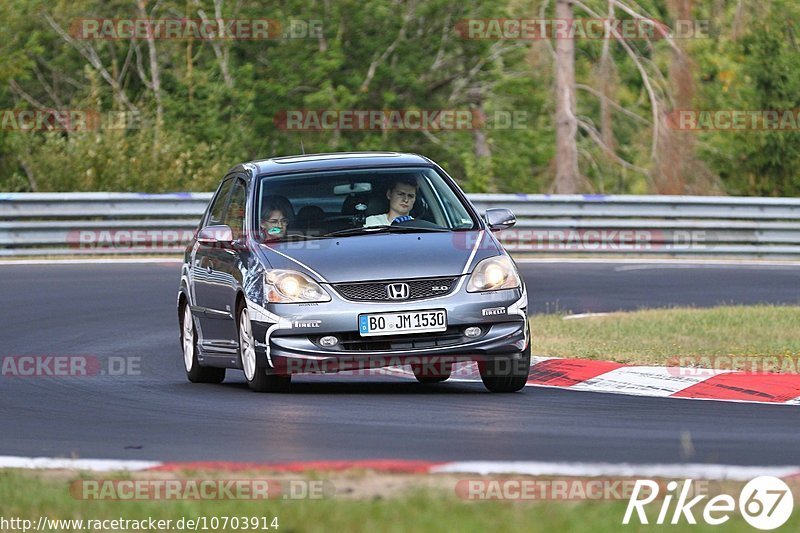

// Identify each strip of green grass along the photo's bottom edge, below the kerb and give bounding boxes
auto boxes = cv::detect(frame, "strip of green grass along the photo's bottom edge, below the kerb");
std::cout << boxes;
[0,470,800,533]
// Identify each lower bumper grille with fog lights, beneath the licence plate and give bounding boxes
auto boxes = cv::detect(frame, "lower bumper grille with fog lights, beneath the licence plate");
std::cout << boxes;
[311,327,486,352]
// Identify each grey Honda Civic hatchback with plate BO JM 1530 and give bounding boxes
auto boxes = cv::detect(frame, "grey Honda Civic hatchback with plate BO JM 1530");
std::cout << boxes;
[177,152,531,392]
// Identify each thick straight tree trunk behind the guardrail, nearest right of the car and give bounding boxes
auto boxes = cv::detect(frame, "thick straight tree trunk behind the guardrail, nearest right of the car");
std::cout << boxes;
[555,0,580,194]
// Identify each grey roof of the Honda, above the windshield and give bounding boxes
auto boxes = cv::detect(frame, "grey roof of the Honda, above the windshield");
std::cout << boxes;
[231,152,433,175]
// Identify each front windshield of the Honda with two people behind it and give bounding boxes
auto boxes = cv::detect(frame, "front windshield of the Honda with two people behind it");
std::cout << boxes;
[257,167,477,241]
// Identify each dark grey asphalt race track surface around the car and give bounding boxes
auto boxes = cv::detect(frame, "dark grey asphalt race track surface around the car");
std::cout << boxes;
[0,263,800,465]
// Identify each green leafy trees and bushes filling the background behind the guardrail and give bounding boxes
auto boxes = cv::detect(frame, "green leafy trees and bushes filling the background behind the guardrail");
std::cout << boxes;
[0,0,800,195]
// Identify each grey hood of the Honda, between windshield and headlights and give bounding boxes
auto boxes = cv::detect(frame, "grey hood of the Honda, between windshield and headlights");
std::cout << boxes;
[259,231,499,283]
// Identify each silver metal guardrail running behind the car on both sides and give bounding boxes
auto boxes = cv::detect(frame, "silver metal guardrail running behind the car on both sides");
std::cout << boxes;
[0,193,800,259]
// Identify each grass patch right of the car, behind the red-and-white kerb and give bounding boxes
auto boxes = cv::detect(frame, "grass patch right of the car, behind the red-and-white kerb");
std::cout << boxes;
[531,306,800,369]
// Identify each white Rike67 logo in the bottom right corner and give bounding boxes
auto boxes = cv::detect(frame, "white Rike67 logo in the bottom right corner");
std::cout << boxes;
[622,476,794,531]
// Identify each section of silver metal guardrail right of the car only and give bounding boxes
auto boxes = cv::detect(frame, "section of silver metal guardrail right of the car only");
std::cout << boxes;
[484,195,800,259]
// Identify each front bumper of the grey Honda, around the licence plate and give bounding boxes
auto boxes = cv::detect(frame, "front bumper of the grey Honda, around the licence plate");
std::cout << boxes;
[248,287,529,374]
